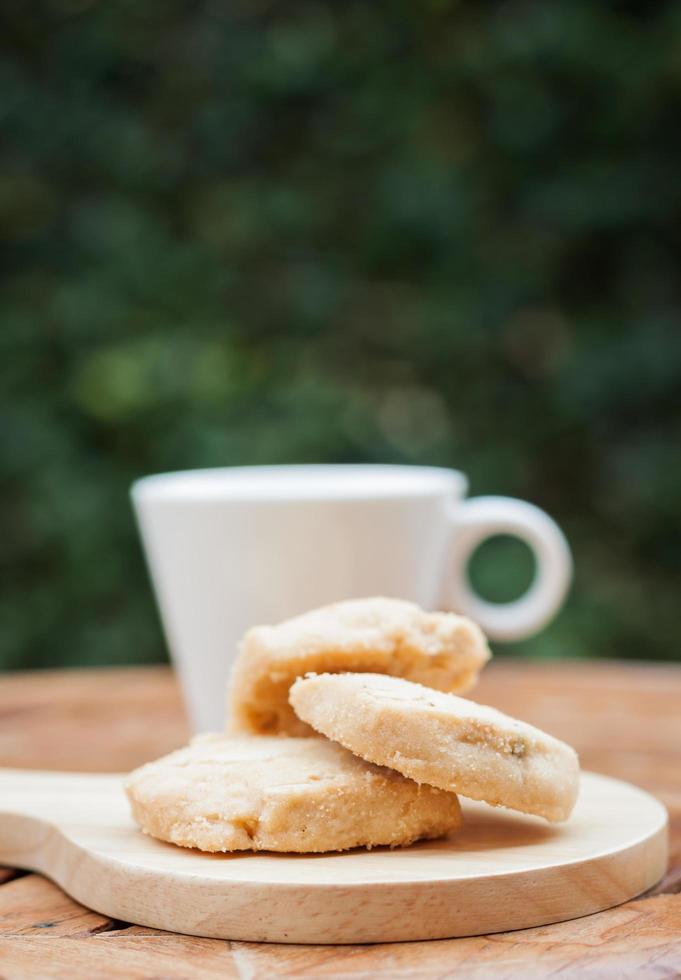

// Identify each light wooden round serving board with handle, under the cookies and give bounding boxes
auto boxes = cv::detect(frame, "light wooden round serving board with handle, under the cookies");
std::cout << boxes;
[0,769,667,943]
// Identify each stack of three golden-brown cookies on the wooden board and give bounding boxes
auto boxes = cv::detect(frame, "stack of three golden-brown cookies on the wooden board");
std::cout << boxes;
[127,598,579,853]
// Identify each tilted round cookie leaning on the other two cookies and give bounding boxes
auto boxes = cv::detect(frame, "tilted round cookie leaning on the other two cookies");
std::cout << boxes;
[290,674,579,821]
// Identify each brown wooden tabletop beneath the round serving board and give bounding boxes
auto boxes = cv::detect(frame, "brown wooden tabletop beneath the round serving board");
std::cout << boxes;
[0,660,681,980]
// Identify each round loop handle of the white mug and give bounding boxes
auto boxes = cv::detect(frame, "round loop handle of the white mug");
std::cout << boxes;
[445,497,572,640]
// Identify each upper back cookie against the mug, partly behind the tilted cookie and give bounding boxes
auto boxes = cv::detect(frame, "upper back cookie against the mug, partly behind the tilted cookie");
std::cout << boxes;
[229,598,490,735]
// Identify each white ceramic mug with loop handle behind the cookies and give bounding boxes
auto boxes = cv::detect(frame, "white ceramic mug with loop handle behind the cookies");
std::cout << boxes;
[132,465,572,730]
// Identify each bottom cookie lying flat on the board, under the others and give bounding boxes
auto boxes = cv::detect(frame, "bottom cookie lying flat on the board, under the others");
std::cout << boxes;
[126,735,461,853]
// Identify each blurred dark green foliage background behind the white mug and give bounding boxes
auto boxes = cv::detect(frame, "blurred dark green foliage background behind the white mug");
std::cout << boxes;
[0,0,681,668]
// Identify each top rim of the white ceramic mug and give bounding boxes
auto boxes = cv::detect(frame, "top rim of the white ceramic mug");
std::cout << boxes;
[130,463,468,504]
